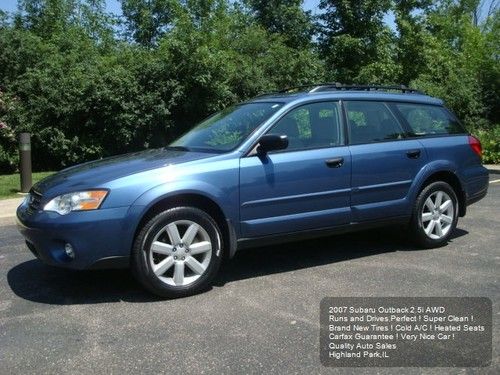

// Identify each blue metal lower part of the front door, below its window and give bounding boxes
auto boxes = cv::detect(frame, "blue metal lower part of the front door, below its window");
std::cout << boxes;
[240,146,351,237]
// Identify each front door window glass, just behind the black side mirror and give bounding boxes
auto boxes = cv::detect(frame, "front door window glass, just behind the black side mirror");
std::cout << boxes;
[268,102,342,150]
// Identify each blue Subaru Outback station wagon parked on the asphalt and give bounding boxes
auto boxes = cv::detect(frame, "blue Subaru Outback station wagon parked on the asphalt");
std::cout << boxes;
[17,84,488,297]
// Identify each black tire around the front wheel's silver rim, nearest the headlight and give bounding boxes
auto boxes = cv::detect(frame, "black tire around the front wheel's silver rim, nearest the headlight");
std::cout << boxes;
[131,207,223,298]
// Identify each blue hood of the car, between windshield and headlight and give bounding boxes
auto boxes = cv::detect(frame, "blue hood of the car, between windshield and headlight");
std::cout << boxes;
[33,148,215,194]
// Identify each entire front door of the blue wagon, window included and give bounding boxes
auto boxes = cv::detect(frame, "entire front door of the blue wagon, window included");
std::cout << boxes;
[240,102,351,238]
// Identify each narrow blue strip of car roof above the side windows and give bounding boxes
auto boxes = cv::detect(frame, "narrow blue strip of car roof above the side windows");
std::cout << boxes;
[247,90,443,105]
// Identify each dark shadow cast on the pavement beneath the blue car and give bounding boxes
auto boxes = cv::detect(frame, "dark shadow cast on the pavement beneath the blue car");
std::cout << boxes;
[7,228,468,305]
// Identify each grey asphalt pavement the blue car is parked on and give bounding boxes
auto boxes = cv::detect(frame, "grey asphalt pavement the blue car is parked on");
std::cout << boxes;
[0,174,500,374]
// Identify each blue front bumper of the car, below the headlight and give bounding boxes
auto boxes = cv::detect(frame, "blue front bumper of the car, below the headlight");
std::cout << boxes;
[17,203,134,269]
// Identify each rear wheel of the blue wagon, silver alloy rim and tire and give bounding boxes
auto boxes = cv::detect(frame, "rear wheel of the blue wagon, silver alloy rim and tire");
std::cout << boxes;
[410,181,459,248]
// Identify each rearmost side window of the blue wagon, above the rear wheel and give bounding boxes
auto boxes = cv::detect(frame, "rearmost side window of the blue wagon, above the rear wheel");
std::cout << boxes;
[396,103,464,136]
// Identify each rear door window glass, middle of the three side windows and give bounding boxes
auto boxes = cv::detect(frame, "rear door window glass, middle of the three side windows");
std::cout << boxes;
[345,101,404,144]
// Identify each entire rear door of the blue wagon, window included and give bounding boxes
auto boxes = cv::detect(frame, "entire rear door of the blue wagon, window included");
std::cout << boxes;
[344,101,427,222]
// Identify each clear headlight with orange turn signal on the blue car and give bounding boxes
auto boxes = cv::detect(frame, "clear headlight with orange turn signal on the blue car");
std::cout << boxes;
[43,190,108,215]
